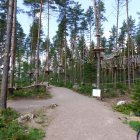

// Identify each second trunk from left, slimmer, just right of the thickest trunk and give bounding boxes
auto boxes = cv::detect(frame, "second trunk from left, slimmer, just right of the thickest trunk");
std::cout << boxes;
[10,0,17,91]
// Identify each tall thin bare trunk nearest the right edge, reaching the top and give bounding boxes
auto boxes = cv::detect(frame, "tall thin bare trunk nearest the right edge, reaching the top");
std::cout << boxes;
[126,0,131,89]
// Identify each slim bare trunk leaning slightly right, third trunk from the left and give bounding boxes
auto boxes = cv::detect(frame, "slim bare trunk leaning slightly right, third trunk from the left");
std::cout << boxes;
[36,0,43,84]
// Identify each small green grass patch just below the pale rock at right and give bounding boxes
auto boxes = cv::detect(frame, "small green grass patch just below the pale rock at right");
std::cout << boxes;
[113,104,132,115]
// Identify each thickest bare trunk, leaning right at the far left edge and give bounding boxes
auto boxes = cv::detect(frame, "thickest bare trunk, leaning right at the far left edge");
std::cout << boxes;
[0,0,14,108]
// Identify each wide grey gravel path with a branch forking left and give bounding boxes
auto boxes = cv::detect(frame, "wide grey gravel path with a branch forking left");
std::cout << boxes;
[8,87,136,140]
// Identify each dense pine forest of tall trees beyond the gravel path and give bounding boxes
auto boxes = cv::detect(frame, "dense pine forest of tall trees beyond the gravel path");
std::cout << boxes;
[0,0,140,113]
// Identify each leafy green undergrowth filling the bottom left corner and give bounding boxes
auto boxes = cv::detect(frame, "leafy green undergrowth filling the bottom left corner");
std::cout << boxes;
[0,108,45,140]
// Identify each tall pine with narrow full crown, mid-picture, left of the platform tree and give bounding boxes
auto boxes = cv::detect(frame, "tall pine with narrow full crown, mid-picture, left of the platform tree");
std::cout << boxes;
[68,2,84,83]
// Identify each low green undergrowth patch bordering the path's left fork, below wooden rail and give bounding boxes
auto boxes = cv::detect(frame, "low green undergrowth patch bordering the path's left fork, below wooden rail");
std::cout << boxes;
[10,86,51,99]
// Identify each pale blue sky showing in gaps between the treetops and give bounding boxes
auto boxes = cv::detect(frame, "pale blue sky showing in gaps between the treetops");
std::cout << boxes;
[17,0,140,42]
